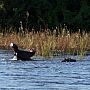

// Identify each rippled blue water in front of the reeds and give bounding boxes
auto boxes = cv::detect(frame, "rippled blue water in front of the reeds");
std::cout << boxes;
[0,50,90,90]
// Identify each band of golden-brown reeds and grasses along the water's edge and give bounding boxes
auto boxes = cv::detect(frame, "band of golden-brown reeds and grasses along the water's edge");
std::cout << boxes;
[0,28,90,56]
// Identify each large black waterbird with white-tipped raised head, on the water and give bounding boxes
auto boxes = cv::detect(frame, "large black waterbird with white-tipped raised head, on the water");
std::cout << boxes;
[10,43,36,60]
